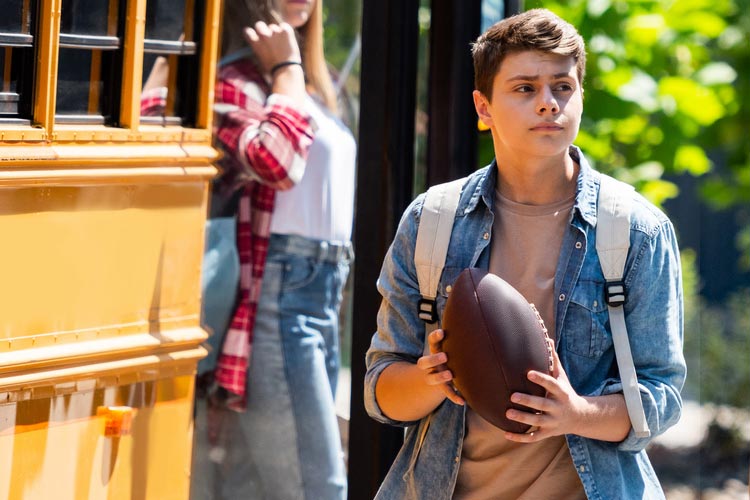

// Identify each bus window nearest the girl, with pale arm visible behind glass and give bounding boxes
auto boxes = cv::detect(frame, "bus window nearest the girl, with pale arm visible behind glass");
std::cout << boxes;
[141,0,200,126]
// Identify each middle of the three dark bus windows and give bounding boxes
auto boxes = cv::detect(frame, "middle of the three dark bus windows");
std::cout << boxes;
[55,0,121,124]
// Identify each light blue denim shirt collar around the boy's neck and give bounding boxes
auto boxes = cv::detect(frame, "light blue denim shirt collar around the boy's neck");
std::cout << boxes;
[463,145,599,227]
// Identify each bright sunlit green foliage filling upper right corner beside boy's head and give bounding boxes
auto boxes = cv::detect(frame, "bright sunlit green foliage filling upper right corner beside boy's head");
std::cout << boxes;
[526,0,750,206]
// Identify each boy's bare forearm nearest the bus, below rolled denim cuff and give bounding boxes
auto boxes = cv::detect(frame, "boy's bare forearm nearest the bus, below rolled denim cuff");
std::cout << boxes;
[375,362,445,422]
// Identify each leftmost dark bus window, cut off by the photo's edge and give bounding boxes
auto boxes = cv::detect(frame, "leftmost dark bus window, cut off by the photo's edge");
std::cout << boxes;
[0,0,36,125]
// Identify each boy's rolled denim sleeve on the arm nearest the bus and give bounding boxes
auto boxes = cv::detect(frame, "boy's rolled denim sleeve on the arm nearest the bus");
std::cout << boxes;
[364,195,432,426]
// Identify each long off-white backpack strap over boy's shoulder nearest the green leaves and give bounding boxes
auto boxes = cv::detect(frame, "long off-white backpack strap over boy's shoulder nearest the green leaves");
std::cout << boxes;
[596,175,651,437]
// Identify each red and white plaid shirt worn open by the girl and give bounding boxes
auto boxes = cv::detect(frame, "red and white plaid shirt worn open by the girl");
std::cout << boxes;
[214,58,315,410]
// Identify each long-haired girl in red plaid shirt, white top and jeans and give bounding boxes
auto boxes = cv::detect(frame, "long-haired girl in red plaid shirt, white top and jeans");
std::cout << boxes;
[201,0,356,500]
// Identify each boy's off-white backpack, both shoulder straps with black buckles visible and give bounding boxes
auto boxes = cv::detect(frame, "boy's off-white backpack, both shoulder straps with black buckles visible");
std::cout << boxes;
[414,174,651,438]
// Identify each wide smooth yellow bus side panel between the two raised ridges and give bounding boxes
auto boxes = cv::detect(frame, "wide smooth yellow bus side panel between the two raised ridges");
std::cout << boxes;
[0,182,206,339]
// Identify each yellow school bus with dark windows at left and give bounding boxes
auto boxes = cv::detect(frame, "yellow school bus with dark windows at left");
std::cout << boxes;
[0,0,220,500]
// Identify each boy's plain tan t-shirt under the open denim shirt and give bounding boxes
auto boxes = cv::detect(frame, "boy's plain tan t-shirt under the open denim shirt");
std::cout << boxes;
[453,188,586,500]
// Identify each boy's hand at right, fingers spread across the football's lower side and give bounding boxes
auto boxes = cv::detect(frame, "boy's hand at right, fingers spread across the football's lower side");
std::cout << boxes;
[505,340,587,443]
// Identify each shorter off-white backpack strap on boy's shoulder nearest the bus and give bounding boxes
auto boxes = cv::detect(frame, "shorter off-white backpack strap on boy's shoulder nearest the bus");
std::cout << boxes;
[414,178,466,349]
